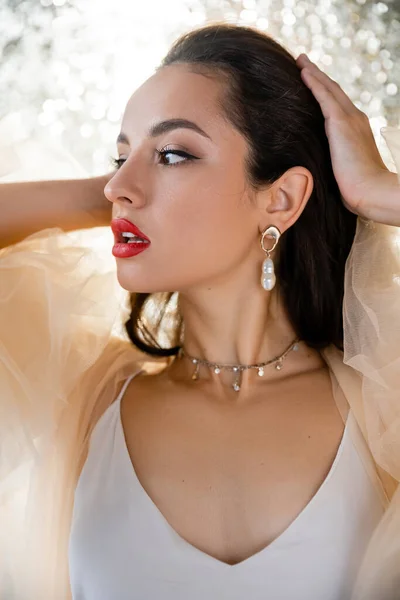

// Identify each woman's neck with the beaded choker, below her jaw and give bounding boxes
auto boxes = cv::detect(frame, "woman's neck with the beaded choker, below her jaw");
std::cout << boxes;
[169,276,323,394]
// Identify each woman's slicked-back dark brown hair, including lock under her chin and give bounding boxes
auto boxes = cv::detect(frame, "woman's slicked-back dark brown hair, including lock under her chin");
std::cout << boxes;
[125,24,357,357]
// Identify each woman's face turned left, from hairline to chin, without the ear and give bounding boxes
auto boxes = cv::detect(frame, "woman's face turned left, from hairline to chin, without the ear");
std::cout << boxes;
[104,65,263,292]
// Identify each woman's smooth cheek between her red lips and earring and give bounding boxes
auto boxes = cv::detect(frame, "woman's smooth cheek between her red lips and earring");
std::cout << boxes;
[157,174,254,274]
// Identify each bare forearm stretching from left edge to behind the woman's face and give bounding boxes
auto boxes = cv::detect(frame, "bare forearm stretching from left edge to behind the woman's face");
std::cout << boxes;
[0,173,112,248]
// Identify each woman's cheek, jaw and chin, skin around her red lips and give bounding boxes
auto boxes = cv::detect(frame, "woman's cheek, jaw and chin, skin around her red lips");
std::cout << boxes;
[117,169,255,292]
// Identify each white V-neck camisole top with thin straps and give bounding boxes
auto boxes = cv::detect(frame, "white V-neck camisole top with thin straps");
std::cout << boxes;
[69,375,384,600]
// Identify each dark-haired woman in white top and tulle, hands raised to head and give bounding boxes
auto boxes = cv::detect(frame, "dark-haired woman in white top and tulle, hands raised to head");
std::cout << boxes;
[0,25,400,600]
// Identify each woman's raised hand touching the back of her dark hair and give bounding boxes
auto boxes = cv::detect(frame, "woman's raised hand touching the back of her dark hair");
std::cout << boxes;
[296,54,400,225]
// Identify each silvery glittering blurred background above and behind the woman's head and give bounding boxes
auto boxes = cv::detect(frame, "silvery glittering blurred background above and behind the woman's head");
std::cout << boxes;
[0,0,400,180]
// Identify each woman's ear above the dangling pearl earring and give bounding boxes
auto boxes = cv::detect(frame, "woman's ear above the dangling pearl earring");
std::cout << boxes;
[258,167,314,233]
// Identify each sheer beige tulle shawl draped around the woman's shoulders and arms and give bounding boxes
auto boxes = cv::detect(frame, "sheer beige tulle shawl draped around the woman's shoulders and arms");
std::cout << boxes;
[0,128,400,600]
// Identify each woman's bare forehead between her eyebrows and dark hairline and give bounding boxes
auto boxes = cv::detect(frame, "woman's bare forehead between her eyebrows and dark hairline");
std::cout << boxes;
[121,65,225,135]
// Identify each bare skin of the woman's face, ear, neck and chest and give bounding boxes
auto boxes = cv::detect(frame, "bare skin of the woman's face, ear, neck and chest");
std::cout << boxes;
[104,65,354,566]
